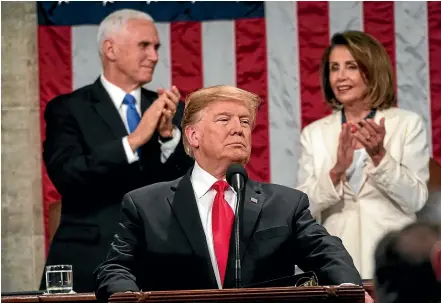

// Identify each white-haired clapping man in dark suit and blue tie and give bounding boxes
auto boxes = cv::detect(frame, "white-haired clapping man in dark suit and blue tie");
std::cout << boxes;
[40,10,193,292]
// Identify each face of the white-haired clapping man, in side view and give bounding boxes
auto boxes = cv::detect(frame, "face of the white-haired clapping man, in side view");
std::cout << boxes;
[113,20,159,85]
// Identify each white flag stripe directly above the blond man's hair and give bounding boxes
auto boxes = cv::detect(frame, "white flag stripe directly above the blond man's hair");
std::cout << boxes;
[202,21,236,87]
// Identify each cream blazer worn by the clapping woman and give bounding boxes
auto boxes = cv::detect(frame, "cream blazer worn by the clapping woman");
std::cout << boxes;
[297,108,430,279]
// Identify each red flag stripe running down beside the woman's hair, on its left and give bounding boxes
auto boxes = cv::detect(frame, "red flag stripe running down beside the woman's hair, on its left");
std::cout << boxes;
[297,1,331,127]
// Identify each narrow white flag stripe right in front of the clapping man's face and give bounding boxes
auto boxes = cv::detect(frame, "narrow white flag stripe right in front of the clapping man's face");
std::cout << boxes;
[145,22,171,91]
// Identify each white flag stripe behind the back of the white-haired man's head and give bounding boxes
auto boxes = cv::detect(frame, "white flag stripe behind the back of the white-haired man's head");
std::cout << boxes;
[72,25,101,90]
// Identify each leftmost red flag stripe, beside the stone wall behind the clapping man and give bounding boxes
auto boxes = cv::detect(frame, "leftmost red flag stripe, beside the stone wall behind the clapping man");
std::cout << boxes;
[38,26,73,252]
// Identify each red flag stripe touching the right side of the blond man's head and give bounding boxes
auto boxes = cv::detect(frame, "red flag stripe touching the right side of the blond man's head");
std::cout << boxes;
[235,18,271,182]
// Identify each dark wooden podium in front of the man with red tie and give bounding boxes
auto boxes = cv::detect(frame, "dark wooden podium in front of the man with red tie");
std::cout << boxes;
[109,286,365,303]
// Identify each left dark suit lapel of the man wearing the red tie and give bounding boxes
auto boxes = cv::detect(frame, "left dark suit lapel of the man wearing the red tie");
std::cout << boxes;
[167,170,217,285]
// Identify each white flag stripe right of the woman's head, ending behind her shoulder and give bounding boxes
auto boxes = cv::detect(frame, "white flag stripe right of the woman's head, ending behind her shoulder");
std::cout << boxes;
[394,1,432,157]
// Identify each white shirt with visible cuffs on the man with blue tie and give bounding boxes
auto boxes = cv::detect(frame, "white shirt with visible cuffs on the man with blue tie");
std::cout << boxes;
[100,75,181,164]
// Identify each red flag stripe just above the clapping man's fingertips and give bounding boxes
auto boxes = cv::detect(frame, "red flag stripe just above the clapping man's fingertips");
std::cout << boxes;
[170,22,203,99]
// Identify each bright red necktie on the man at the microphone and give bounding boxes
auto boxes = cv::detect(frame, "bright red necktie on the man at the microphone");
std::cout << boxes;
[211,181,234,285]
